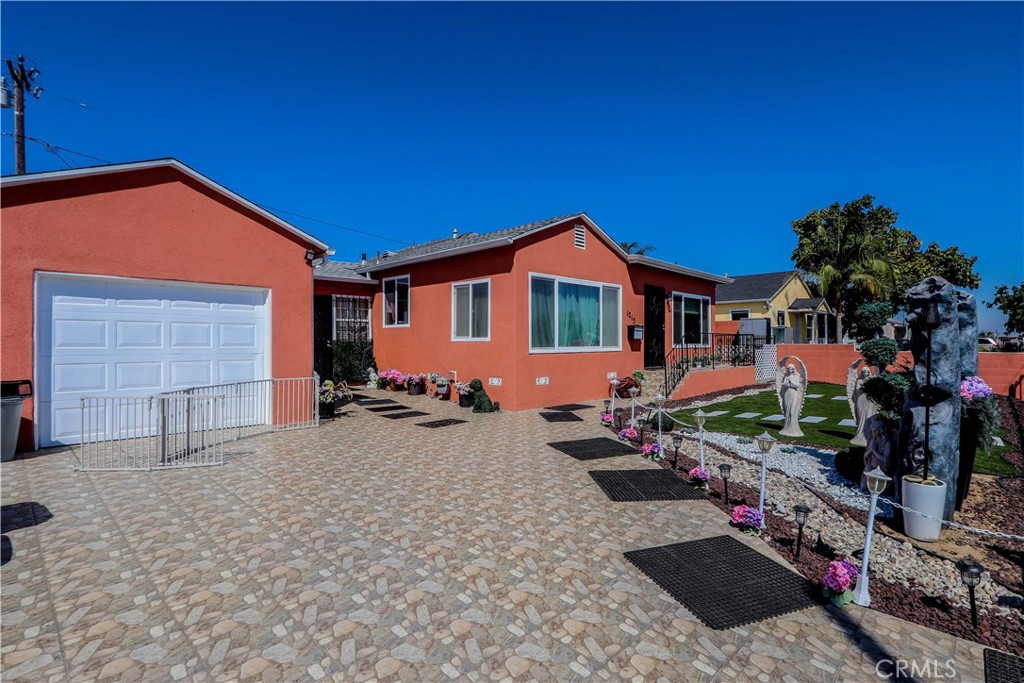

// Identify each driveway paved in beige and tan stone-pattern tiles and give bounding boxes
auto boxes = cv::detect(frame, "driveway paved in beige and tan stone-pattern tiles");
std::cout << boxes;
[0,396,983,681]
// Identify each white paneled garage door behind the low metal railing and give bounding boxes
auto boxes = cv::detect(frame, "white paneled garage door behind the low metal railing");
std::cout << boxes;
[36,275,269,446]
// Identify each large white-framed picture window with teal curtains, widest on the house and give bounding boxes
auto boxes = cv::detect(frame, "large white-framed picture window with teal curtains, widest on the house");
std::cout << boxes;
[529,272,623,353]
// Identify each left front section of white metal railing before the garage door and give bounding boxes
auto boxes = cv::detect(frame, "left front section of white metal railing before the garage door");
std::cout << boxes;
[78,394,224,470]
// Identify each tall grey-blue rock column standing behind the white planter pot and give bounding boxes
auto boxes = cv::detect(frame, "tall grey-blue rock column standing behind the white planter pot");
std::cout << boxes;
[900,276,962,520]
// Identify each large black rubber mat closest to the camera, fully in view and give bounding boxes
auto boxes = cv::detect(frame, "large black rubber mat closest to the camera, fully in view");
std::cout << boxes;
[624,536,815,630]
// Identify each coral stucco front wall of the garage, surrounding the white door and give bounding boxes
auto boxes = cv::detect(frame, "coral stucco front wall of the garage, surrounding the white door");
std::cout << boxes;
[0,168,312,450]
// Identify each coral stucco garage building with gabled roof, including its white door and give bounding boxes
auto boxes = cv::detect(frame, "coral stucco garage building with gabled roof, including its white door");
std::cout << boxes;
[0,159,330,451]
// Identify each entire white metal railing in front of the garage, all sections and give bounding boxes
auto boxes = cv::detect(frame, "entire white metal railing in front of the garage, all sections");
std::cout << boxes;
[78,375,319,470]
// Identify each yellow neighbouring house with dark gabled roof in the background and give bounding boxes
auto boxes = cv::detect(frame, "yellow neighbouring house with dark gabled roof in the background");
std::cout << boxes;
[715,270,836,344]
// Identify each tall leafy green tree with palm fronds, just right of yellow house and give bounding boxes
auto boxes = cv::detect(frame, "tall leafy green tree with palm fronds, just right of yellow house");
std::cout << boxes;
[793,195,897,332]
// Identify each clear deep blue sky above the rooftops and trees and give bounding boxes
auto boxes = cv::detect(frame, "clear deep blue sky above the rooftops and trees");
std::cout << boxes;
[0,0,1024,330]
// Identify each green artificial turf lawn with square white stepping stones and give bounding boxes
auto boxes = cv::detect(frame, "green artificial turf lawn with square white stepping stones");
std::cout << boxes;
[673,382,1016,475]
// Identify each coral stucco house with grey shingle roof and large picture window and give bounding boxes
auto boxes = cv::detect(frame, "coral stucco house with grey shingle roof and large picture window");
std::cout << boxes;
[314,213,731,410]
